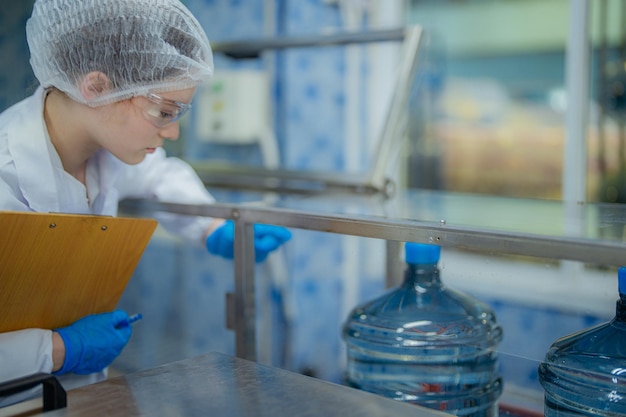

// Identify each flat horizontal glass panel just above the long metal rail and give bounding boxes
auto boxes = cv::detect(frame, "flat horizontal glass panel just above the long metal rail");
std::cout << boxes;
[272,189,626,242]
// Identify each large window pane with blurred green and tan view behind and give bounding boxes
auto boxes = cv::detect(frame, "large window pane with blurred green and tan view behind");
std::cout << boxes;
[407,0,569,198]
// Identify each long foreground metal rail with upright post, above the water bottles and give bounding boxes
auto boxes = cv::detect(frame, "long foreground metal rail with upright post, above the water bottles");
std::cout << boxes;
[123,200,626,360]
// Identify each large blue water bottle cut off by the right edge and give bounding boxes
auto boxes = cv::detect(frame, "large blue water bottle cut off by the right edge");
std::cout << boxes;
[539,267,626,417]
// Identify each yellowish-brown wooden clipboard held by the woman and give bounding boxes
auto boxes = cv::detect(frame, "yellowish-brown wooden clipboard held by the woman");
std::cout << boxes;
[0,211,157,332]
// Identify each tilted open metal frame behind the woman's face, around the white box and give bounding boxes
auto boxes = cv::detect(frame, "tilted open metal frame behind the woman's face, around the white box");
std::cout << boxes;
[192,26,422,196]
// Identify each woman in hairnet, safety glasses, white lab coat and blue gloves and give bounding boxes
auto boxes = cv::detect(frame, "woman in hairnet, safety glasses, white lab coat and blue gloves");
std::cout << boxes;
[0,0,290,405]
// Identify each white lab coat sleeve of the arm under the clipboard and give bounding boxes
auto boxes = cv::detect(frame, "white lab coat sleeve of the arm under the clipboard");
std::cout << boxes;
[0,329,53,407]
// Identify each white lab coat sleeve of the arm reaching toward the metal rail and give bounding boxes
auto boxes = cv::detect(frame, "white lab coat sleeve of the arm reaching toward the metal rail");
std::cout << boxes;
[118,149,215,244]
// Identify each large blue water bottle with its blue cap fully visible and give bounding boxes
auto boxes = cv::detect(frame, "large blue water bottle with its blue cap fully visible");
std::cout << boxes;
[343,243,502,417]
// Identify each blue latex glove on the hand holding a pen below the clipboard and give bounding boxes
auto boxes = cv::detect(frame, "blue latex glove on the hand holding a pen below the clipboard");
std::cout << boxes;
[54,310,132,375]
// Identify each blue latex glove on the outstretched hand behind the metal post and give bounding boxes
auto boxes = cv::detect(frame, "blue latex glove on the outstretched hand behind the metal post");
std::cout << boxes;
[206,220,291,262]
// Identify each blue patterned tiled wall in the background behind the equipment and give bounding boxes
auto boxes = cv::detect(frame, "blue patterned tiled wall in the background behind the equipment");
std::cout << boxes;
[0,0,605,404]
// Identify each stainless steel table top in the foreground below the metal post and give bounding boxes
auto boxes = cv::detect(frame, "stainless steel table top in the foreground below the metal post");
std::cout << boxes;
[4,353,448,417]
